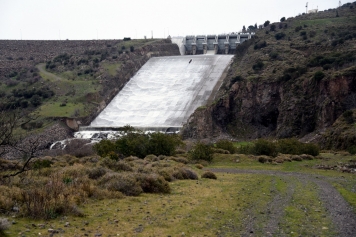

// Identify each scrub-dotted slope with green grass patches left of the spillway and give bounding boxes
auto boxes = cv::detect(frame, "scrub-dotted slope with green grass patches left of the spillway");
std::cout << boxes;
[0,39,179,130]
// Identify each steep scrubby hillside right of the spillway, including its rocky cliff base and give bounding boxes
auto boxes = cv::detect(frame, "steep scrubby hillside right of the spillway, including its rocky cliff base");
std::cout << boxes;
[183,3,356,149]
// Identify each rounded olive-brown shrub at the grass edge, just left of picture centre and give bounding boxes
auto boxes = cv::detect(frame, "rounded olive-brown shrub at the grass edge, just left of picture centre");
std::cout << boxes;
[138,174,171,193]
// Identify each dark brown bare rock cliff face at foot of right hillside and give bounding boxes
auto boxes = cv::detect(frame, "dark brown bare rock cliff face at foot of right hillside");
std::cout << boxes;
[183,67,356,139]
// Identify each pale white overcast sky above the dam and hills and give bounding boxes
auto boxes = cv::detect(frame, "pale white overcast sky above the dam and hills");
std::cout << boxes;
[0,0,346,40]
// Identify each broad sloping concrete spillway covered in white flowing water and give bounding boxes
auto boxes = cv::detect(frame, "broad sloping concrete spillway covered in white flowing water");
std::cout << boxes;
[87,55,233,130]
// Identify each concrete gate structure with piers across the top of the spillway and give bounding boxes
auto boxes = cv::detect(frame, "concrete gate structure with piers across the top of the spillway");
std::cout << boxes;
[172,32,255,55]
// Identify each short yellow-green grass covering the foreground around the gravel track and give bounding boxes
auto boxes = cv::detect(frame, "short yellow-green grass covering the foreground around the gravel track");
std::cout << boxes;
[0,153,356,236]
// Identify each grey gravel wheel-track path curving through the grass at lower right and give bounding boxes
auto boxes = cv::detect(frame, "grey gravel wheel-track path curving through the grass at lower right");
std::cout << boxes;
[209,168,356,237]
